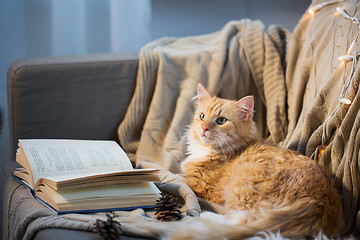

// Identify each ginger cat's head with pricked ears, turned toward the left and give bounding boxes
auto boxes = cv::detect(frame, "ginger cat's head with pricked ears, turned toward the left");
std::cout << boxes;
[190,84,254,149]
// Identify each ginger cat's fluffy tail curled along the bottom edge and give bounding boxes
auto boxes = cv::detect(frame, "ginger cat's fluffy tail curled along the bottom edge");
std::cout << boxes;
[164,199,340,240]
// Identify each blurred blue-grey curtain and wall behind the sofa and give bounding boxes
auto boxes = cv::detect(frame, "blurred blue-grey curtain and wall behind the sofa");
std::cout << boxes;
[0,0,311,167]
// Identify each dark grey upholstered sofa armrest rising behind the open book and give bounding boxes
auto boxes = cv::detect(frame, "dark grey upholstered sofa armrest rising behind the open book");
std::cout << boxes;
[7,53,138,160]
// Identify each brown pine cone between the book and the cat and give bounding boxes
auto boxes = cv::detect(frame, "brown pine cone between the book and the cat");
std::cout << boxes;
[154,195,181,221]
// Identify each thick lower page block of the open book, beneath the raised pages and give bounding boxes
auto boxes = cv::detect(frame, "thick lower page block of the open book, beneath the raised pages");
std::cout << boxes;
[36,182,161,212]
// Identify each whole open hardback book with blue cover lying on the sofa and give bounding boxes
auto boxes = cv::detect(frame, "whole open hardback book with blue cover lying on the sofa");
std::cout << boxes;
[13,139,160,213]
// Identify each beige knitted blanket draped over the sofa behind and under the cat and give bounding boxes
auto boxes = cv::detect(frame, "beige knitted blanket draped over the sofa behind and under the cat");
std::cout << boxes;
[4,1,360,239]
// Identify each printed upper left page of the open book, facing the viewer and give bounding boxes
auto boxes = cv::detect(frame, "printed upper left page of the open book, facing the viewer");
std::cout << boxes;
[19,139,133,183]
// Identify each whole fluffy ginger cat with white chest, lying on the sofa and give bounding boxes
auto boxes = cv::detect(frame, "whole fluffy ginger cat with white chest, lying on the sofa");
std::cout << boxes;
[171,84,341,239]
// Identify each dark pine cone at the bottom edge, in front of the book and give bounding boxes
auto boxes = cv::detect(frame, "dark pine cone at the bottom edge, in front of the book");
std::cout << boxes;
[94,213,123,240]
